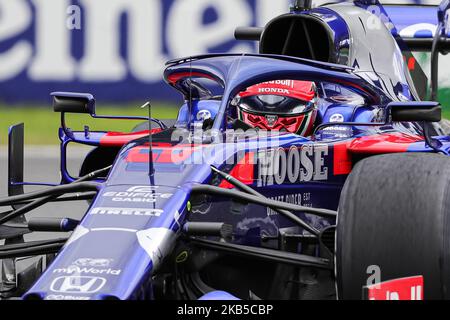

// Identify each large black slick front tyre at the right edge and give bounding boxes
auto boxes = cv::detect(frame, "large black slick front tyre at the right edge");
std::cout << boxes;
[336,153,450,299]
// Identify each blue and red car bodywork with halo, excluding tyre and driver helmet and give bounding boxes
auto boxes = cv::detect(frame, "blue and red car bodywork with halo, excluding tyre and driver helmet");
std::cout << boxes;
[0,0,450,300]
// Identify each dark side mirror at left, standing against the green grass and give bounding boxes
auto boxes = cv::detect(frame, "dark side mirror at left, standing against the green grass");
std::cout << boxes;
[51,92,95,115]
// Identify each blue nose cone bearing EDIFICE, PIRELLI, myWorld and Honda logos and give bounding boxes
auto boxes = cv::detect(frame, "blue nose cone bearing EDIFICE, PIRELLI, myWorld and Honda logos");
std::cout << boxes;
[24,185,188,300]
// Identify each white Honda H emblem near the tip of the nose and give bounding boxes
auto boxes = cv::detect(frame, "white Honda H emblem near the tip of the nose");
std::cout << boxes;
[50,276,106,293]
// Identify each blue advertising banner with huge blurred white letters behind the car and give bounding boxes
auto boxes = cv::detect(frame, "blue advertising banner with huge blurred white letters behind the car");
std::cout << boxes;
[0,0,450,105]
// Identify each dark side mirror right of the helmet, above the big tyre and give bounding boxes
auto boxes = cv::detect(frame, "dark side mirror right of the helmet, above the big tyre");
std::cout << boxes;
[388,101,442,122]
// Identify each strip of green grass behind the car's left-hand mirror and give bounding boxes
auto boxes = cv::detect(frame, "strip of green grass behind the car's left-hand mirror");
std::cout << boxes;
[0,103,178,145]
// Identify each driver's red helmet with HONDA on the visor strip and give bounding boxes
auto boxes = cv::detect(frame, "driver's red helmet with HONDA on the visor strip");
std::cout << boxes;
[236,80,317,136]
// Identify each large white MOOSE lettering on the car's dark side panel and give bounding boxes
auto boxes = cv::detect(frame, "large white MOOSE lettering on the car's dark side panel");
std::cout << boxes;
[257,144,328,186]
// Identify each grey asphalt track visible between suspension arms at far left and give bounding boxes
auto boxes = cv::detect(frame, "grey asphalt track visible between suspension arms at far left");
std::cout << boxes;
[0,146,90,240]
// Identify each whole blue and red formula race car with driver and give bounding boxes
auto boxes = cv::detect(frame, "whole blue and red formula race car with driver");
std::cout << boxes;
[0,1,450,300]
